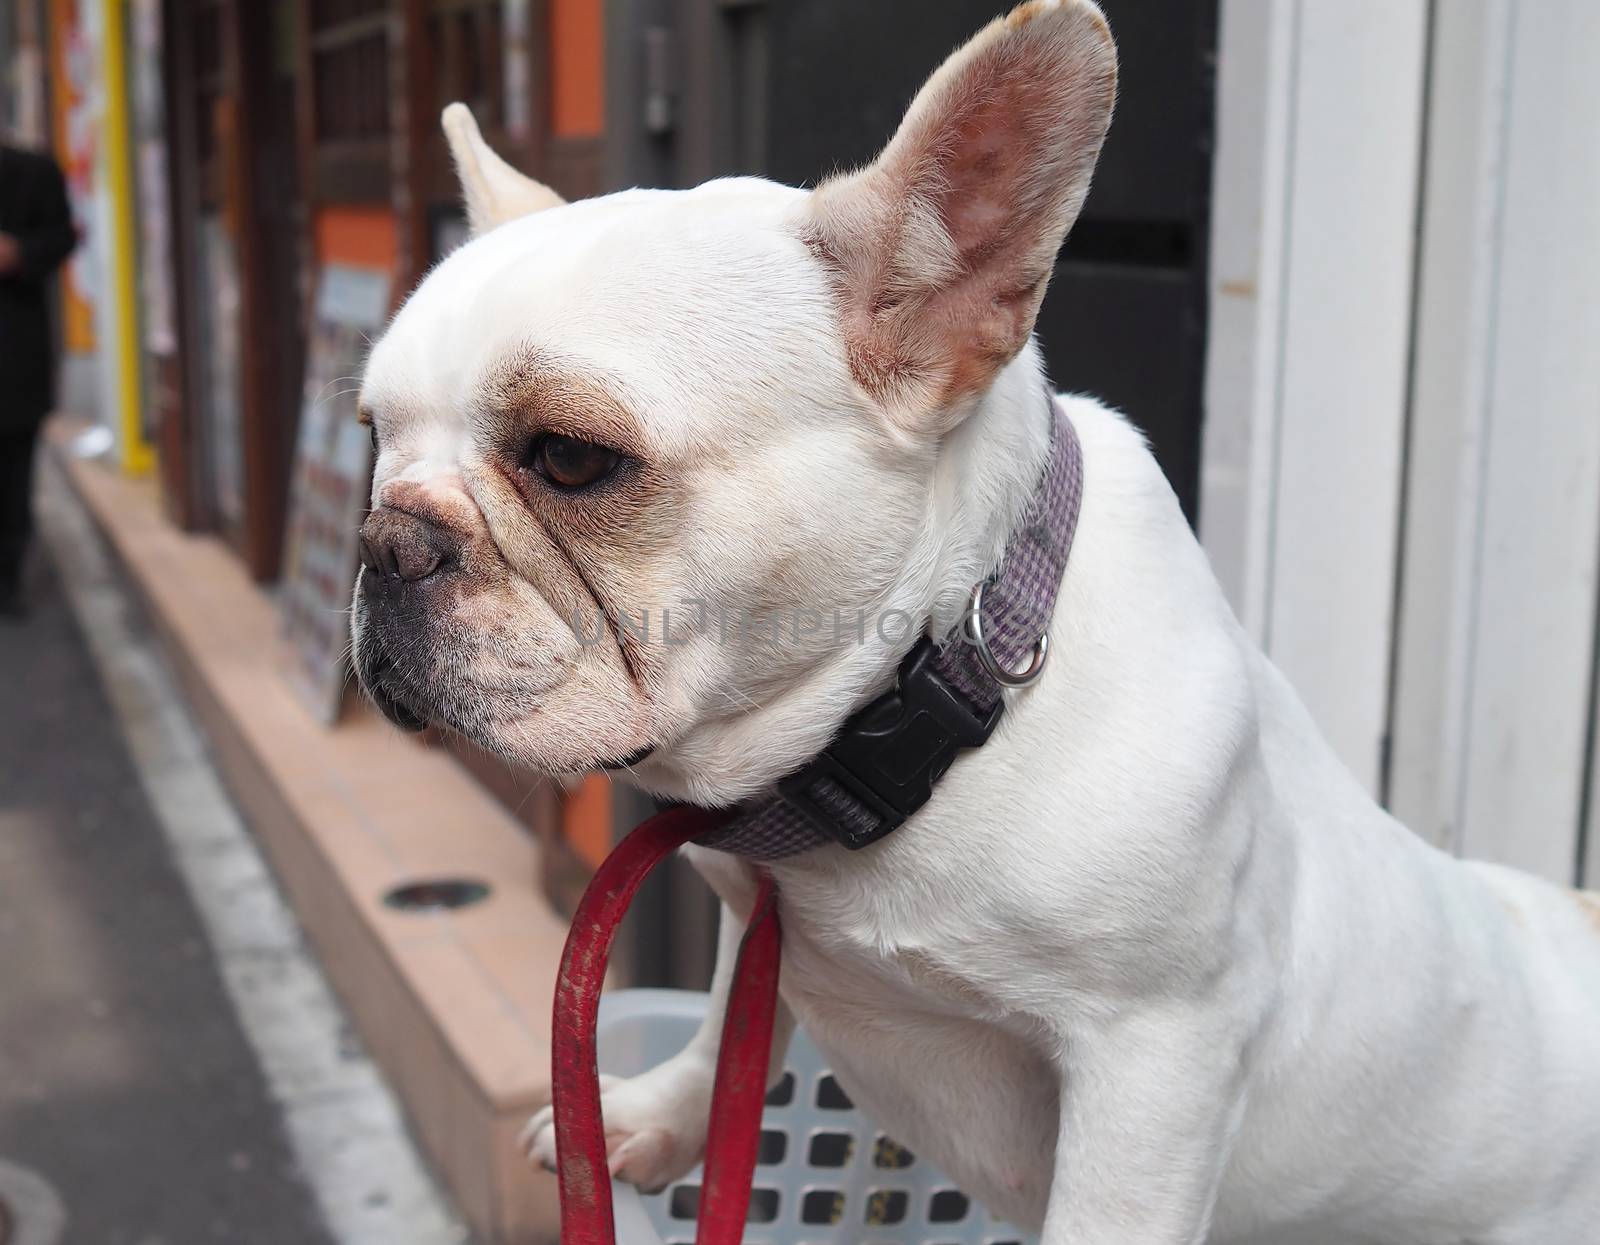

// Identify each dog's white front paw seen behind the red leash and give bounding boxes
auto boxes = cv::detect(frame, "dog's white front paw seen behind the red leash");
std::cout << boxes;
[522,1064,710,1192]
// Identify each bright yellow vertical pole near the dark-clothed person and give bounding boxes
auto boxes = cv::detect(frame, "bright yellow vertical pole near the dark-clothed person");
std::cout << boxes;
[102,0,155,475]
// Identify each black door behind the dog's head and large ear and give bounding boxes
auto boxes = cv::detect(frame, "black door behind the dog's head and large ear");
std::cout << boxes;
[608,0,1216,522]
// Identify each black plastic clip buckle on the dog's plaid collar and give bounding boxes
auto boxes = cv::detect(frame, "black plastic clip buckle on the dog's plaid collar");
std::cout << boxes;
[778,637,1005,850]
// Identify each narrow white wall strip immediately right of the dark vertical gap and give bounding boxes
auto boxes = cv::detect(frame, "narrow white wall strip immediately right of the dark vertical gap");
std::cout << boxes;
[1389,0,1514,848]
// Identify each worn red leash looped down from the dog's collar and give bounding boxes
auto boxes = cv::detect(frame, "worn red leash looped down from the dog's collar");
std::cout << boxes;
[550,808,781,1245]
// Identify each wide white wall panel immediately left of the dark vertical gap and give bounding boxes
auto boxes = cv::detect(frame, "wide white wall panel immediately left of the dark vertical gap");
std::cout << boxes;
[1266,0,1427,791]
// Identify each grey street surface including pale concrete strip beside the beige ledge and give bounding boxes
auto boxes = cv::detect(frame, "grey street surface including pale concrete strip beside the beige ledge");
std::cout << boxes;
[0,451,464,1245]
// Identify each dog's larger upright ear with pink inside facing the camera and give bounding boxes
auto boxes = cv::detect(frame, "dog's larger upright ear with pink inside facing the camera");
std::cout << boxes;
[805,0,1117,432]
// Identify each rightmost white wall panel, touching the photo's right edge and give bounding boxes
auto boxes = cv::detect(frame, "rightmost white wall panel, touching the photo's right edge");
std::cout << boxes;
[1461,0,1600,882]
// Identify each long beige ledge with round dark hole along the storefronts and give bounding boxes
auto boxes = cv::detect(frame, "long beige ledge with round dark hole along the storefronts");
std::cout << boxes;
[53,429,565,1245]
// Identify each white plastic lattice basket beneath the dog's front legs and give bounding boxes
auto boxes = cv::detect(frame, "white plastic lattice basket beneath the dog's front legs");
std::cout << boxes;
[598,991,1032,1245]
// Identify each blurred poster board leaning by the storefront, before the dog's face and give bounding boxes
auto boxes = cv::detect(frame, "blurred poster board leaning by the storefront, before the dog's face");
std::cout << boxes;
[280,264,389,725]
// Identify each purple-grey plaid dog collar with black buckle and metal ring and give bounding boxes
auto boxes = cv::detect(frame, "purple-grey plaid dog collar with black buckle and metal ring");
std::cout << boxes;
[698,394,1083,861]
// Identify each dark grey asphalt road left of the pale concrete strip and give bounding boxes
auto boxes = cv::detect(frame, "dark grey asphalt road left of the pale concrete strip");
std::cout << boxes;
[0,554,330,1245]
